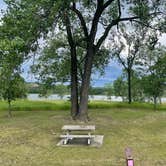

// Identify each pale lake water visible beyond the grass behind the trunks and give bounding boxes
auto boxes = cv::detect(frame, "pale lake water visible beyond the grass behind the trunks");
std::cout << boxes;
[28,94,166,103]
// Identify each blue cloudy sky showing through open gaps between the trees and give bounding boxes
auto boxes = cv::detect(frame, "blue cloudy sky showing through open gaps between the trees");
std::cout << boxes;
[0,0,166,87]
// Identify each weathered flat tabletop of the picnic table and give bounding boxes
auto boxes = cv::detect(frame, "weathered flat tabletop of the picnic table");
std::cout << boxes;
[62,125,95,131]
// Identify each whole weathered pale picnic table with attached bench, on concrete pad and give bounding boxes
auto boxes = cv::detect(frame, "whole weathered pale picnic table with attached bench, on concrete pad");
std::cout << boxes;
[60,125,95,145]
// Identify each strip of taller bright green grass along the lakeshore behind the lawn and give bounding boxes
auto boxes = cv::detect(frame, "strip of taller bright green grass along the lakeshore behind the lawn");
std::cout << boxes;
[0,100,166,111]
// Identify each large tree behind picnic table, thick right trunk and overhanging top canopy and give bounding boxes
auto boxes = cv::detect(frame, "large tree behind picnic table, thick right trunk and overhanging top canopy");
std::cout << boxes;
[1,0,163,120]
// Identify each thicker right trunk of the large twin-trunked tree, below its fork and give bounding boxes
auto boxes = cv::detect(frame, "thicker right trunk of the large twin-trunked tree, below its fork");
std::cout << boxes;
[78,47,94,121]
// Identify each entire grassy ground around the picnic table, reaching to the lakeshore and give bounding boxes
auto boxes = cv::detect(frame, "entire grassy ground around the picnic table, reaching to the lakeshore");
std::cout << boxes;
[0,101,166,166]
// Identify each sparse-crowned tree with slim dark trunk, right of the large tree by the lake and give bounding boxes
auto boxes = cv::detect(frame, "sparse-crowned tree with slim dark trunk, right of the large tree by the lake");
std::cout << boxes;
[111,23,158,103]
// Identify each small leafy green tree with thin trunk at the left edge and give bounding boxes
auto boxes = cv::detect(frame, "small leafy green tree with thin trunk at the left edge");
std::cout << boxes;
[0,36,26,116]
